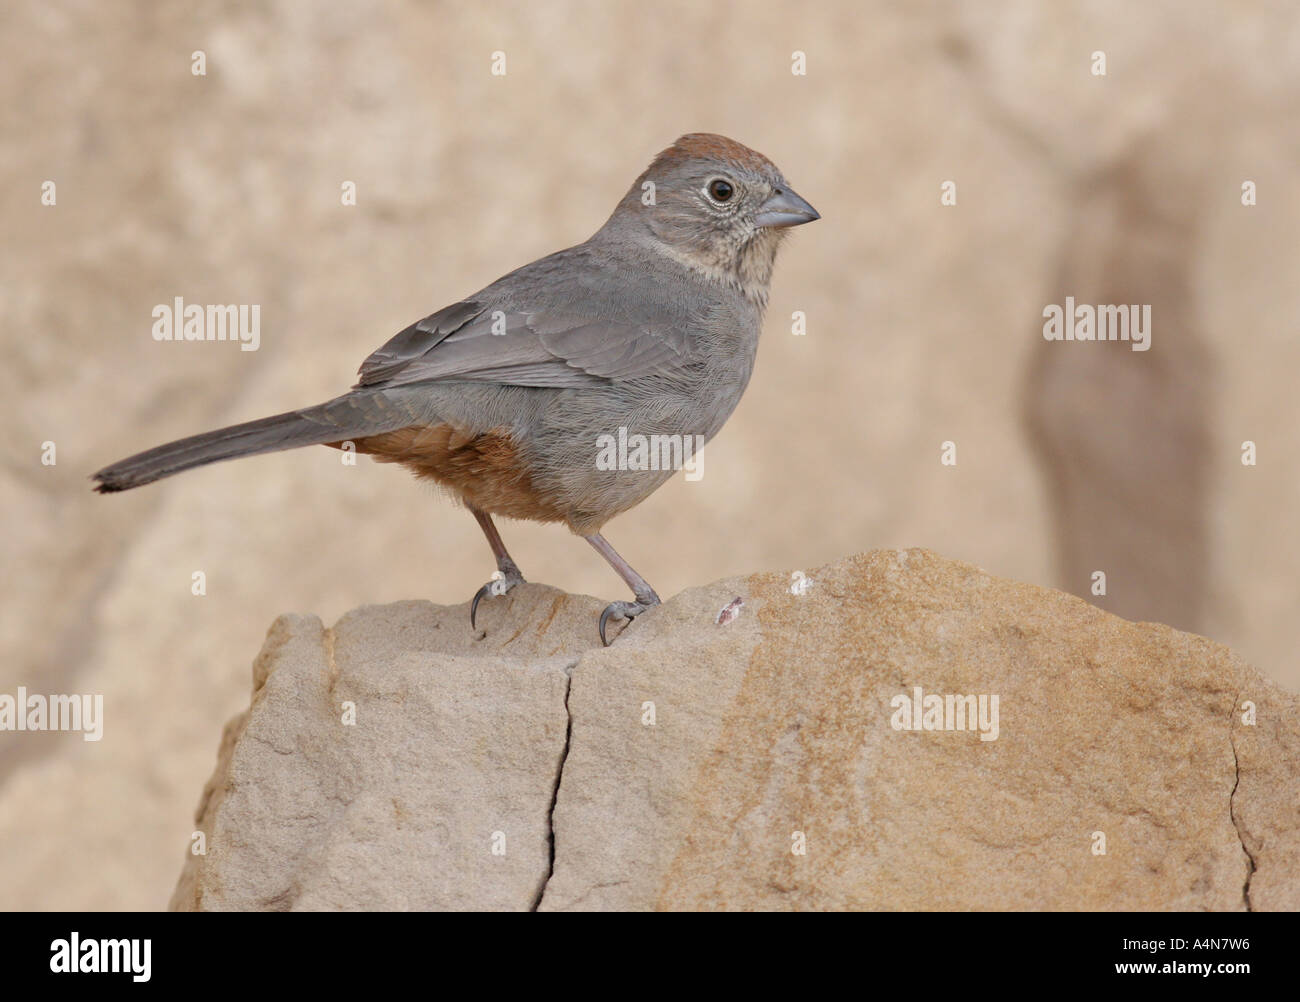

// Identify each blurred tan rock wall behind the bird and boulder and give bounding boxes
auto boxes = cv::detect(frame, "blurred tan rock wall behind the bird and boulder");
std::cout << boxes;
[0,0,1300,908]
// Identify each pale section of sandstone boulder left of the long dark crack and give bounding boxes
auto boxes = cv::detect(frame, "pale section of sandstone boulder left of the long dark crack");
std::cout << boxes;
[172,587,585,910]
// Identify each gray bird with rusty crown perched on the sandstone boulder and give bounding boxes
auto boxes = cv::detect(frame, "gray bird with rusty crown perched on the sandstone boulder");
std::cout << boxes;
[92,133,820,646]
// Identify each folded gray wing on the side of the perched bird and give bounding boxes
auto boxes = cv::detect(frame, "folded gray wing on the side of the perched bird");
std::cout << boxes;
[356,302,690,387]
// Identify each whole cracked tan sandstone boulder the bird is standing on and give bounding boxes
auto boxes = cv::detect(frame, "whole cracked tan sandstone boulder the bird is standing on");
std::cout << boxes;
[172,550,1300,911]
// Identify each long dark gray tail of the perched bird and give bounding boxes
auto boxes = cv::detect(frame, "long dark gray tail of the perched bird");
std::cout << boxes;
[91,392,415,494]
